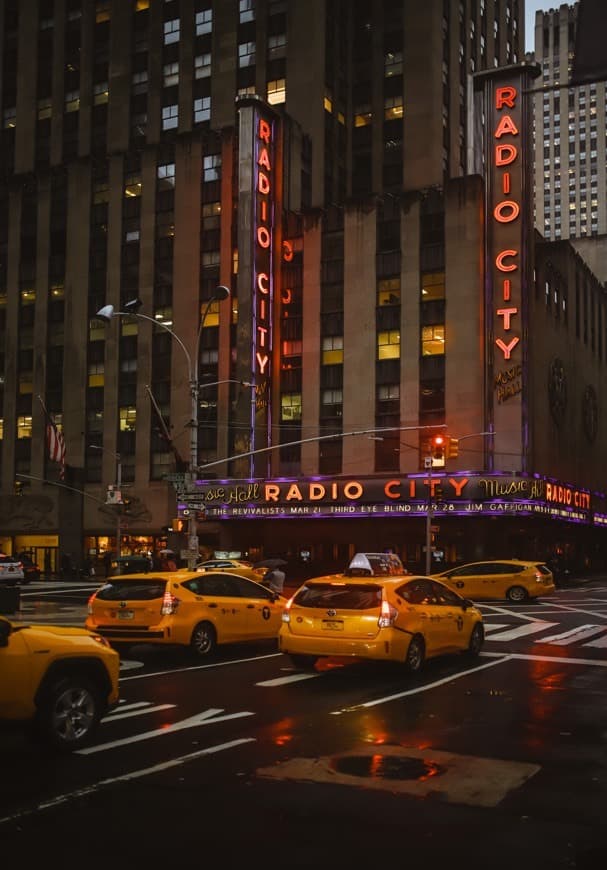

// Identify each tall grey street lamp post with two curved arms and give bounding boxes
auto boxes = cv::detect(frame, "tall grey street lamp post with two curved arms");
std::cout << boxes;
[97,284,230,571]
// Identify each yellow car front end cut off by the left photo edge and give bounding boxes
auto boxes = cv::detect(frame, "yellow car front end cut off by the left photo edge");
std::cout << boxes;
[0,616,120,751]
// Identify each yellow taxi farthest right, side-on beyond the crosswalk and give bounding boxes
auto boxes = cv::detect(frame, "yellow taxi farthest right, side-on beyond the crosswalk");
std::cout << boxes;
[432,559,555,603]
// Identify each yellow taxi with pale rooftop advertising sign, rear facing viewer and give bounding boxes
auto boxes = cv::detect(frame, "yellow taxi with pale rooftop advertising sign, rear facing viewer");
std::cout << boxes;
[278,553,485,673]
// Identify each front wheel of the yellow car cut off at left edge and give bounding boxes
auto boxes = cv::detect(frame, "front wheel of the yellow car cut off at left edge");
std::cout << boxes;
[34,674,105,752]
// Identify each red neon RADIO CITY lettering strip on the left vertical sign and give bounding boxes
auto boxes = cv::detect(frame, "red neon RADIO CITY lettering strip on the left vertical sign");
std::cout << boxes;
[252,111,275,398]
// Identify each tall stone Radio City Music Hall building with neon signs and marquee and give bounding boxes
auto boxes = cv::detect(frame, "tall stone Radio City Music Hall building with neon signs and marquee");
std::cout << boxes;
[0,0,607,570]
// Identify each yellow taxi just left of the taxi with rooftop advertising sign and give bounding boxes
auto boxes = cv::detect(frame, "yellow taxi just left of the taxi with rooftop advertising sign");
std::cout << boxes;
[85,569,286,658]
